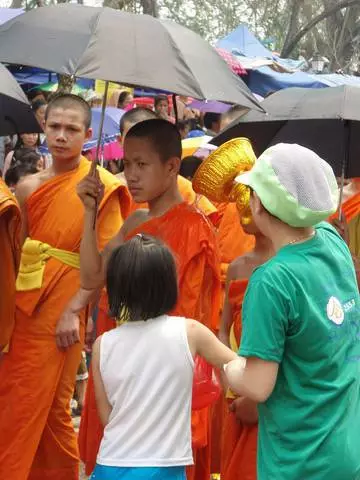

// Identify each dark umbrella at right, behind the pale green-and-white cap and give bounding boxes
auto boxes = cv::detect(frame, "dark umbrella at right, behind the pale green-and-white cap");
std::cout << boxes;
[212,85,360,178]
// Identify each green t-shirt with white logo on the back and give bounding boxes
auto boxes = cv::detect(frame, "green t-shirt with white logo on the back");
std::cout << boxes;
[240,223,360,480]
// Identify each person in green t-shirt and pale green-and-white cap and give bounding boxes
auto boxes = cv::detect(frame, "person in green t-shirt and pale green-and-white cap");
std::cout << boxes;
[225,144,360,480]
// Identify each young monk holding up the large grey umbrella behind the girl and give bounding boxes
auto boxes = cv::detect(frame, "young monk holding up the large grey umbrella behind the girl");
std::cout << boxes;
[79,119,220,480]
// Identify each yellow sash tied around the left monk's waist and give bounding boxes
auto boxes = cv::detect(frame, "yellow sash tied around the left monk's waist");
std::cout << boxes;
[16,238,80,292]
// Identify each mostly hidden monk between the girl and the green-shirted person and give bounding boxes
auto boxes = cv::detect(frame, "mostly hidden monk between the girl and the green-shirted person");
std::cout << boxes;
[219,219,273,480]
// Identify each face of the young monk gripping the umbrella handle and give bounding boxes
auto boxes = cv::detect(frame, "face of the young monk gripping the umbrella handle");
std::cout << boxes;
[124,137,180,203]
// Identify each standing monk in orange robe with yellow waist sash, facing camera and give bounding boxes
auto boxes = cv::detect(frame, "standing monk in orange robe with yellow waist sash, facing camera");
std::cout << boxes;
[0,95,129,480]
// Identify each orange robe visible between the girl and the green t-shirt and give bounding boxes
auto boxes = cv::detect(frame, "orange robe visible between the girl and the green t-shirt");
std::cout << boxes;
[221,280,258,480]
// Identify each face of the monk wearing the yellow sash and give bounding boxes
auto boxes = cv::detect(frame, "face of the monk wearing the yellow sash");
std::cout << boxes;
[45,107,92,163]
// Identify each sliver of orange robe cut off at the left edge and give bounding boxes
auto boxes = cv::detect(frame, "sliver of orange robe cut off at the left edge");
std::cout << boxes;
[0,179,21,348]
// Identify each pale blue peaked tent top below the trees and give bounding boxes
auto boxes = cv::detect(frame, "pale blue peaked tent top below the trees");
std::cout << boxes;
[216,25,273,59]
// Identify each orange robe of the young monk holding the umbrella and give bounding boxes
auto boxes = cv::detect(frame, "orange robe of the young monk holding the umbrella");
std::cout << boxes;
[79,203,220,480]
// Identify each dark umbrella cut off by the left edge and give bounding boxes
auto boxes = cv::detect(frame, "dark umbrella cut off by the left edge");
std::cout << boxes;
[0,64,41,136]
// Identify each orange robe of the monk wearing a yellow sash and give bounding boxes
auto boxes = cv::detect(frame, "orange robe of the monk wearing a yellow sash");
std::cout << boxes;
[0,158,130,480]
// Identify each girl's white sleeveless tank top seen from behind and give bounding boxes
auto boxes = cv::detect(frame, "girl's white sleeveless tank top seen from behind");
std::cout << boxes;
[97,315,194,467]
